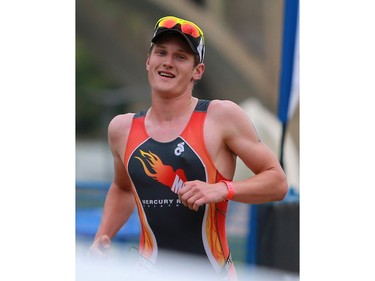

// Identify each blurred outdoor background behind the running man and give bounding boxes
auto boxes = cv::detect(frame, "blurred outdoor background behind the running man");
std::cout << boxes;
[76,0,299,280]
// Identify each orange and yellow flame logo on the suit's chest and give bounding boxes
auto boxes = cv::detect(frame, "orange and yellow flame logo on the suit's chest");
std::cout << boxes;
[135,150,186,190]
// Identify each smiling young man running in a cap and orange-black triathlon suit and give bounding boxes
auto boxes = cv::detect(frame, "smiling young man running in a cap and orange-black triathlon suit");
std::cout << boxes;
[90,16,287,280]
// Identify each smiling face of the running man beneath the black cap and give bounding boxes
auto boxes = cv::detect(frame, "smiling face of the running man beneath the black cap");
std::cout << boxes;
[146,35,204,96]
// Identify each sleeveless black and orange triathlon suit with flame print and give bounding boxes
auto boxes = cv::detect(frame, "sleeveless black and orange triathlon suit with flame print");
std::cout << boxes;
[124,100,235,276]
